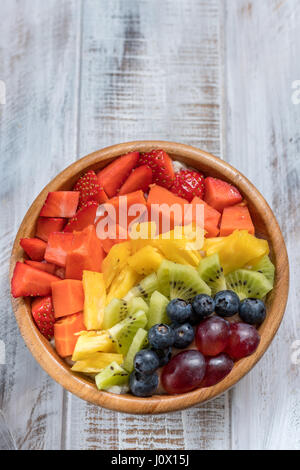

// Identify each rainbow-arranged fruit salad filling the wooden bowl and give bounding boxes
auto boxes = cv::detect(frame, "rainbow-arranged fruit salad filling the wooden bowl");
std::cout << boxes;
[11,149,275,397]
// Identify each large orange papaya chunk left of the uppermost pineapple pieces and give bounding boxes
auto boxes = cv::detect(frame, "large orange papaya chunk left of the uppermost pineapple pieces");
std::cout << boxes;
[66,225,104,280]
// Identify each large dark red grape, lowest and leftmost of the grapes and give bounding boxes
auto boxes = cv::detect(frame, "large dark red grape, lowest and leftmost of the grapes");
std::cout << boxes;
[161,349,206,394]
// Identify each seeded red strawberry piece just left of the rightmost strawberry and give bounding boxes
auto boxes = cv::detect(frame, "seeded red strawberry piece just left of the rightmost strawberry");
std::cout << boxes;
[171,170,204,202]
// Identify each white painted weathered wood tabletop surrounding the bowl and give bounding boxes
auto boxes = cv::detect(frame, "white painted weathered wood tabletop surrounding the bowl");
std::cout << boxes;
[0,0,300,449]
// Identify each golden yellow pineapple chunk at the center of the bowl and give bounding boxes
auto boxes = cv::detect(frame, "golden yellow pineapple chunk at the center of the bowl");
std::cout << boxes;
[128,245,164,276]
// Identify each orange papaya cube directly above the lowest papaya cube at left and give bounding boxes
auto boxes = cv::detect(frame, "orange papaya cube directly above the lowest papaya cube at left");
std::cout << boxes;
[51,279,84,318]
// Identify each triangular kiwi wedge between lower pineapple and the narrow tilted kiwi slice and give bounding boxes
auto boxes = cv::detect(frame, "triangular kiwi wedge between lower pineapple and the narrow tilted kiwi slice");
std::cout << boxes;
[108,310,148,356]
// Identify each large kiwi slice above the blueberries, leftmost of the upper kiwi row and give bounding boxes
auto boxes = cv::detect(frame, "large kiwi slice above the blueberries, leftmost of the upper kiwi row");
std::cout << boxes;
[157,260,211,301]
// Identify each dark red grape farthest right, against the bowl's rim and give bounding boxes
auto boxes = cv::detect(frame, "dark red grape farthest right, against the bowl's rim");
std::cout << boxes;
[225,322,260,360]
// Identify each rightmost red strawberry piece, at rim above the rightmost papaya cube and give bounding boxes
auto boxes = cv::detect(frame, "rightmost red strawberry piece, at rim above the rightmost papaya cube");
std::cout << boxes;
[204,176,243,212]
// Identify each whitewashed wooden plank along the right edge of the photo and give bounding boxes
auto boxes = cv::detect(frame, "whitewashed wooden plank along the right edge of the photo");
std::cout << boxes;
[225,0,300,449]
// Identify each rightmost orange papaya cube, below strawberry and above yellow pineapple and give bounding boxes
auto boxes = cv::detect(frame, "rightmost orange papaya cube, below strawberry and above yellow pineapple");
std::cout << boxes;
[220,205,254,237]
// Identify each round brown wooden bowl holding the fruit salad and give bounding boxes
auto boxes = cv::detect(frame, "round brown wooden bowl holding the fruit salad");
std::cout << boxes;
[10,141,289,414]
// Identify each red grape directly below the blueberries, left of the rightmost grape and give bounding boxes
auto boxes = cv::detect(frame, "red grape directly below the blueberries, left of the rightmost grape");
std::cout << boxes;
[195,316,230,356]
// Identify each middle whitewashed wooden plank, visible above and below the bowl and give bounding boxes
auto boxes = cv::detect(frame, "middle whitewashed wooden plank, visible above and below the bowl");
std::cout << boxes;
[65,0,230,449]
